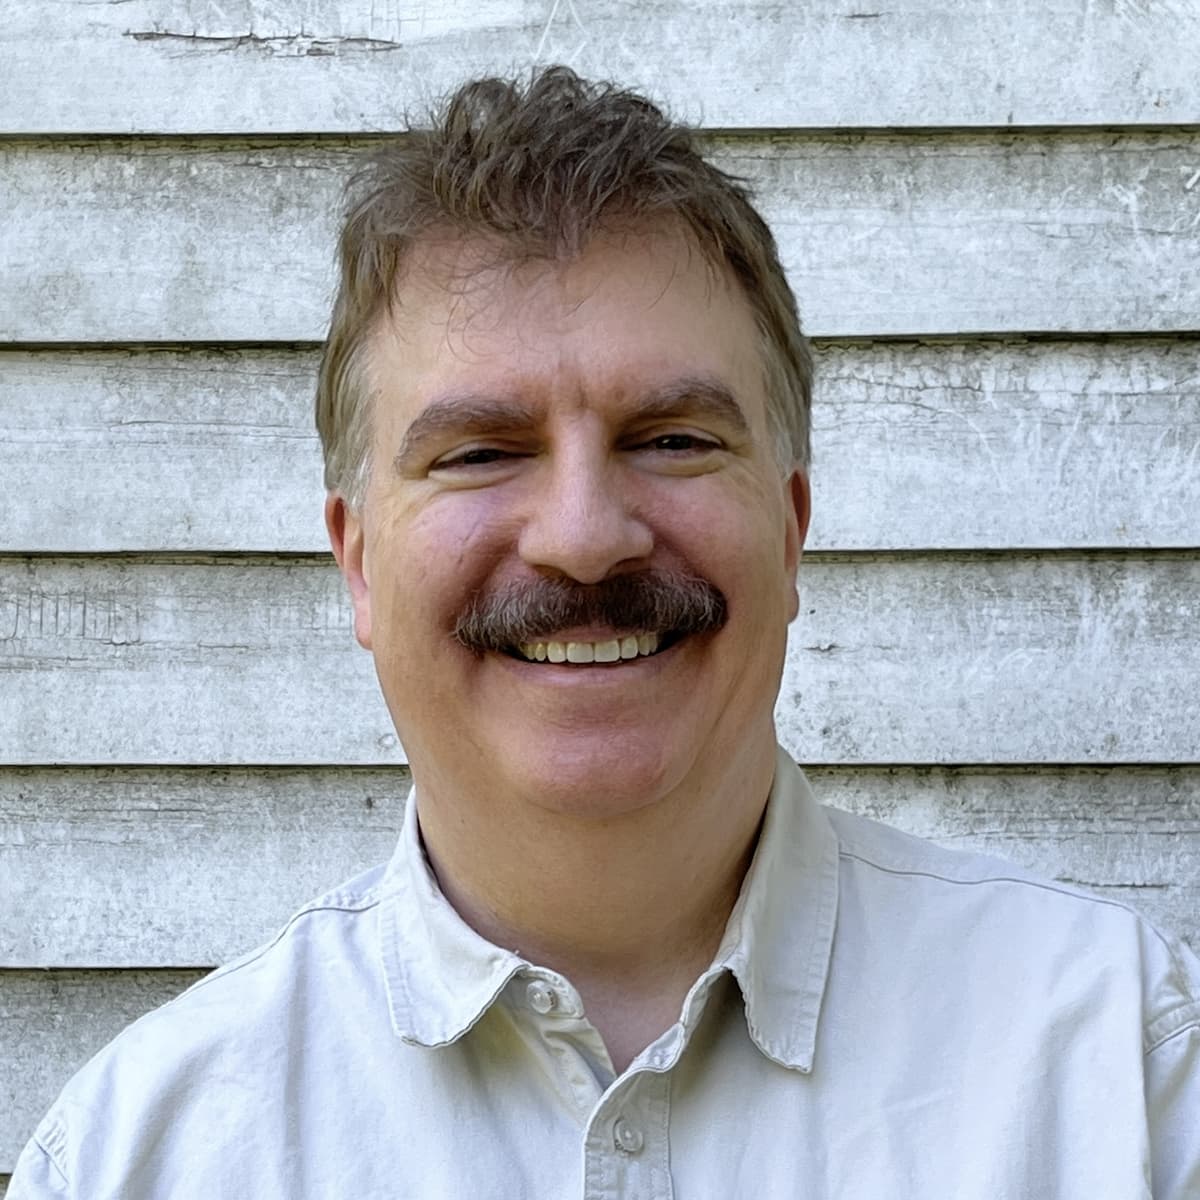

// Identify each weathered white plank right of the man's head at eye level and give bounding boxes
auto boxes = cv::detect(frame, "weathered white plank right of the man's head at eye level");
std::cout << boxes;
[810,340,1200,550]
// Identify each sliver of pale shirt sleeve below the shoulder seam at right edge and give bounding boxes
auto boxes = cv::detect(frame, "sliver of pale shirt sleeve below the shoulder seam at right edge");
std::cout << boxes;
[1146,1004,1200,1200]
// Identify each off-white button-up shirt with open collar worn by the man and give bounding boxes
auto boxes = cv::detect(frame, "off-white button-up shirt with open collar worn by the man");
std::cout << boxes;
[8,754,1200,1200]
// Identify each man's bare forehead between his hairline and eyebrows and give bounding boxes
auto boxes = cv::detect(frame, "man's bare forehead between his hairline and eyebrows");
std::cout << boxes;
[367,222,762,424]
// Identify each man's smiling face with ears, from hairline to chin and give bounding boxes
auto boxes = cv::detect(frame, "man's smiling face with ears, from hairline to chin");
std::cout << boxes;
[329,226,808,815]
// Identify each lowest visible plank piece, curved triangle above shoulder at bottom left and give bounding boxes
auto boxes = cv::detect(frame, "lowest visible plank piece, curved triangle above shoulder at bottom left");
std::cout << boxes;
[0,971,204,1172]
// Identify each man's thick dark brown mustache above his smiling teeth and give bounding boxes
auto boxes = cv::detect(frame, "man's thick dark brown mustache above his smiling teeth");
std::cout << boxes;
[454,570,728,653]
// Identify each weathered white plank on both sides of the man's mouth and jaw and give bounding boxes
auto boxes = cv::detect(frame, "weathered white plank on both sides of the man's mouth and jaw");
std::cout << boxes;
[0,553,1200,764]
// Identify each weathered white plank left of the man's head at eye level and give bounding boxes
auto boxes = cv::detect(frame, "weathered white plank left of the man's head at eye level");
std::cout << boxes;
[0,349,329,553]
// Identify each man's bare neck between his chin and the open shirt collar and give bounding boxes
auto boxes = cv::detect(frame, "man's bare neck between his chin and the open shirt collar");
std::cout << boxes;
[414,738,774,1070]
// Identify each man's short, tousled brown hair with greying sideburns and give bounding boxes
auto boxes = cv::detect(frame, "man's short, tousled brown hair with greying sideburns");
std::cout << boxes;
[317,67,812,508]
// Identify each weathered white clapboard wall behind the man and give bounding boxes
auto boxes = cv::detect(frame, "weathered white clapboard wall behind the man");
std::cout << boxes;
[0,0,1200,1180]
